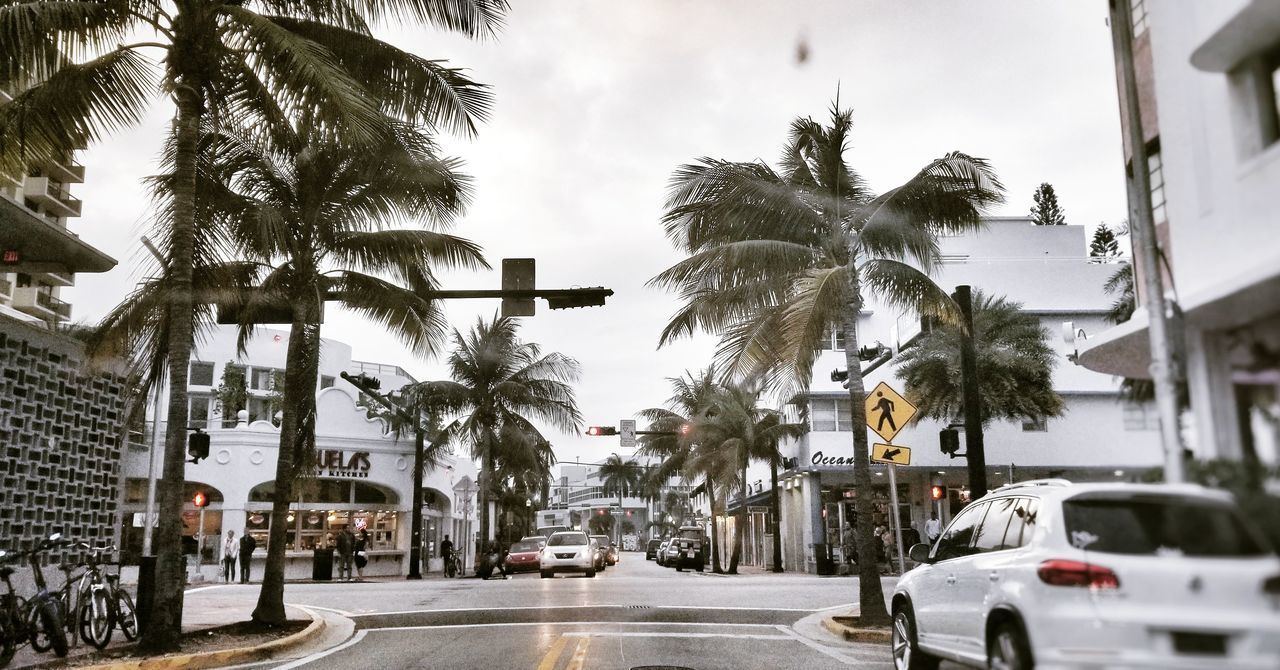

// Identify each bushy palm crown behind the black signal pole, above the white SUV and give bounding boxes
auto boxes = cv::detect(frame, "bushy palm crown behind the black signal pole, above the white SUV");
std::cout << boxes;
[896,291,1062,424]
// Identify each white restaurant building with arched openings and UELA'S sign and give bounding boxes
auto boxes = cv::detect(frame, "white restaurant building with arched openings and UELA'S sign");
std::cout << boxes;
[120,327,477,578]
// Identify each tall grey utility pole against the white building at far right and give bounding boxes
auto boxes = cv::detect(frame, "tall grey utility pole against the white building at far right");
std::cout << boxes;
[1105,0,1185,483]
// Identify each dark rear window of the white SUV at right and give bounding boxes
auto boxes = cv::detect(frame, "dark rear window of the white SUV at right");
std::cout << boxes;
[1062,496,1268,557]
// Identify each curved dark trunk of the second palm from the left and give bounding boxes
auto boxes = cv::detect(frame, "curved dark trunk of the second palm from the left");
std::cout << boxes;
[252,290,320,626]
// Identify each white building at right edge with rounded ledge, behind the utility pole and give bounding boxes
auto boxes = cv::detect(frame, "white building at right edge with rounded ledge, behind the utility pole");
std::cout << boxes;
[1080,0,1280,466]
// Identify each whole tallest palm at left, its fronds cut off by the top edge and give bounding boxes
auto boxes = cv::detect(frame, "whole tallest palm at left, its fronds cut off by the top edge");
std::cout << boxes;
[0,0,506,651]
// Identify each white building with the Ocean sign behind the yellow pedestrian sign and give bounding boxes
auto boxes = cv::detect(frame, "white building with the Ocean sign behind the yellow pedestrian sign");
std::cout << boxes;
[727,217,1161,573]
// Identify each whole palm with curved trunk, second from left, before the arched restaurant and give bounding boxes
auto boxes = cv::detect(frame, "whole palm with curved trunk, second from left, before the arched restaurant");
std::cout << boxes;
[206,119,488,625]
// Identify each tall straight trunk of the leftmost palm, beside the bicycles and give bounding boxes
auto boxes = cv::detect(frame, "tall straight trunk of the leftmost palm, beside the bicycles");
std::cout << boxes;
[140,86,201,653]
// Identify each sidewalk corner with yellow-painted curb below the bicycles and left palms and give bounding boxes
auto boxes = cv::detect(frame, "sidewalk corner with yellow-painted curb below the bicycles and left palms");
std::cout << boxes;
[8,585,340,670]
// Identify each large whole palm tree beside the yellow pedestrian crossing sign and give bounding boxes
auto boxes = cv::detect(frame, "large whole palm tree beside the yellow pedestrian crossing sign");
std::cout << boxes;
[650,101,1002,624]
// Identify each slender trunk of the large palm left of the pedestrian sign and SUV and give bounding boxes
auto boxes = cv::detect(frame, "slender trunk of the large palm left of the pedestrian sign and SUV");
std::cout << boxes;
[839,270,890,625]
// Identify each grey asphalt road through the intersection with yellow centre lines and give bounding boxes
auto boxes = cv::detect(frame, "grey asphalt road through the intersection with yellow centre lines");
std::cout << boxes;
[235,553,892,670]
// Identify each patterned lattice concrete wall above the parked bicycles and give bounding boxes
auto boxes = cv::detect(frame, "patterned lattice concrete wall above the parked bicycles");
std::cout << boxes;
[0,315,124,563]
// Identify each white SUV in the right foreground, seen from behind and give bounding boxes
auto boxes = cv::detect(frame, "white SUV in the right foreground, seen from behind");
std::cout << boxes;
[892,479,1280,670]
